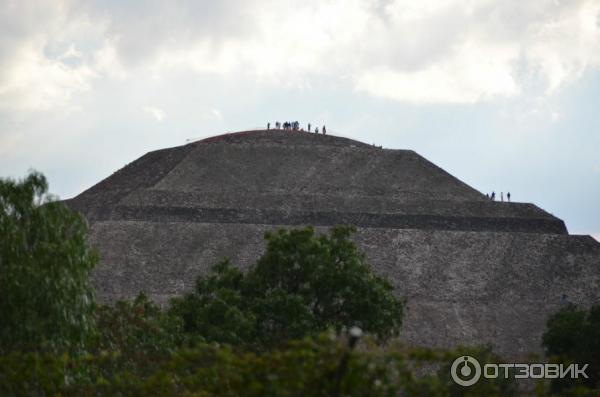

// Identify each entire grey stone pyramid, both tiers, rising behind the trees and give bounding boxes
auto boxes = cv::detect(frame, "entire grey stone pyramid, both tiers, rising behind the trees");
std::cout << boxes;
[66,130,600,357]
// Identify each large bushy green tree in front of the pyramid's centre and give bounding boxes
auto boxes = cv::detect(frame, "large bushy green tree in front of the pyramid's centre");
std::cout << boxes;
[172,226,402,347]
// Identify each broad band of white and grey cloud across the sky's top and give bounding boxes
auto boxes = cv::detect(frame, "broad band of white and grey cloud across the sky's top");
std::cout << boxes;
[0,0,600,111]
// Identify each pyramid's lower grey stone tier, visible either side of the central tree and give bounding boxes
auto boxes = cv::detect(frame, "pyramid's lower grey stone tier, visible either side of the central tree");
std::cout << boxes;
[91,221,600,357]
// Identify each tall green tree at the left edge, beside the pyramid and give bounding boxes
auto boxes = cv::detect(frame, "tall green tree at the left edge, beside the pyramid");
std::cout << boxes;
[0,172,97,352]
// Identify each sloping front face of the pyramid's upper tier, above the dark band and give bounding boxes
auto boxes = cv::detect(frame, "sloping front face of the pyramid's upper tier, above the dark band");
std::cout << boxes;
[154,139,485,201]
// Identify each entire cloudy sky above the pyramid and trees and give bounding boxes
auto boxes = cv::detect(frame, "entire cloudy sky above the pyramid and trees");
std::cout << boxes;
[0,0,600,238]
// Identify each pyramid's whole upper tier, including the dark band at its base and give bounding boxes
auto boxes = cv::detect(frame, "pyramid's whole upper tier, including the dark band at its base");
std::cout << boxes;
[70,131,566,233]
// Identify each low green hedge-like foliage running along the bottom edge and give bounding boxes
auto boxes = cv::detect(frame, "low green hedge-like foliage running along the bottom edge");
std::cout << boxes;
[0,334,518,397]
